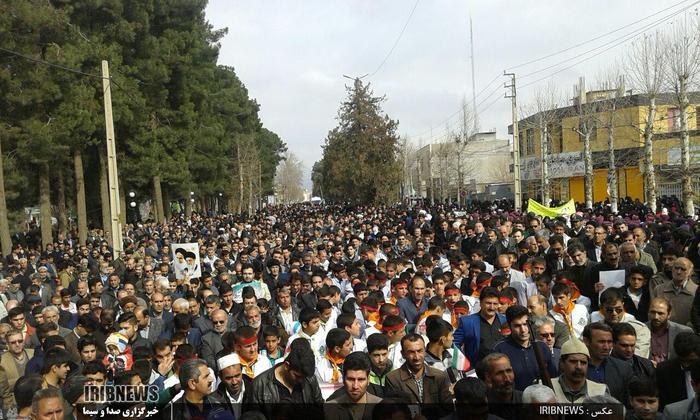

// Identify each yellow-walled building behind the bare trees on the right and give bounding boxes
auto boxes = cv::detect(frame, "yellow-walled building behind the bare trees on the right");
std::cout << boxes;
[518,90,700,202]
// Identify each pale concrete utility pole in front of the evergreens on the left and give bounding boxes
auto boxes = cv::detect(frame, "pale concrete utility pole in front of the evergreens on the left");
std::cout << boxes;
[102,60,122,260]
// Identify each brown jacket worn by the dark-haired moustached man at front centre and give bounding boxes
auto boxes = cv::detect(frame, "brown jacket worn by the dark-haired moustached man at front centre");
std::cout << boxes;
[385,363,452,409]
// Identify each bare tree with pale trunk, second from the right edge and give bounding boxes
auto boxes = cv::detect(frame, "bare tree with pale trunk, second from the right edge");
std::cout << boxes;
[625,32,666,212]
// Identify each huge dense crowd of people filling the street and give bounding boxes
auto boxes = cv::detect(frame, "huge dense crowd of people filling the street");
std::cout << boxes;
[0,200,700,420]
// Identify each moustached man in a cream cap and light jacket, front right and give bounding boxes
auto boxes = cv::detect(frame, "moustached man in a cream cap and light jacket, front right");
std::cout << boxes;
[552,338,610,404]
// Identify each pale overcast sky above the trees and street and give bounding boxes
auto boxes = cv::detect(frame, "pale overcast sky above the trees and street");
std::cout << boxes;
[207,0,696,185]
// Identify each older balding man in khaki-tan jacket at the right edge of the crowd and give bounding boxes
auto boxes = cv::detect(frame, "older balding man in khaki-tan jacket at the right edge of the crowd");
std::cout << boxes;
[651,257,700,331]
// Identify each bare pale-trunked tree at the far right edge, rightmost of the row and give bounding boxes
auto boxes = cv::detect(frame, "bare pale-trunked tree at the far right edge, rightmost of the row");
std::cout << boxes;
[666,16,700,216]
